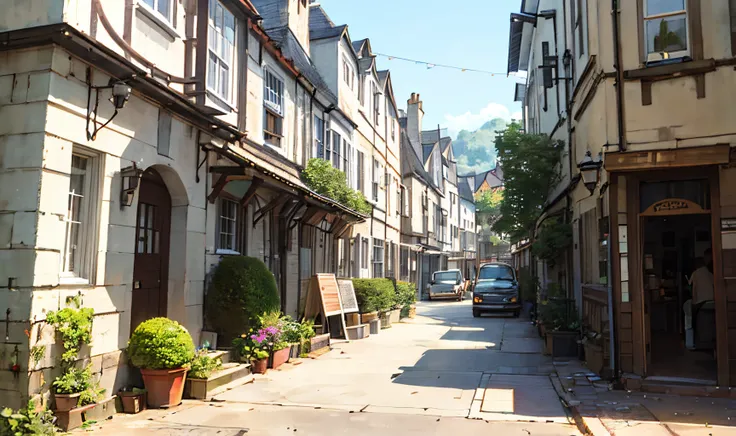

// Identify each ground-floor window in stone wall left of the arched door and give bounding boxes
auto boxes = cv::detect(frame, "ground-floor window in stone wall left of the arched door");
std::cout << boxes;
[61,153,100,279]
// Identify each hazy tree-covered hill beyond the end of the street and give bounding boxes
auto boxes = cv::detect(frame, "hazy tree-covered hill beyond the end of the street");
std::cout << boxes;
[452,118,508,174]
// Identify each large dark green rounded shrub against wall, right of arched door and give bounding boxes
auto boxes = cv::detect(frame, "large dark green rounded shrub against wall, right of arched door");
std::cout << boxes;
[207,256,281,343]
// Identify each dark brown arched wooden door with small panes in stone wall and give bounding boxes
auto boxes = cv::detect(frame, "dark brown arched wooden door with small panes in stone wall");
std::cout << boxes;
[130,169,171,333]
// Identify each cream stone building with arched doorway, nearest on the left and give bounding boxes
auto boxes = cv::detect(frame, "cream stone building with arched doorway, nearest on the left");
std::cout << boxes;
[0,0,368,408]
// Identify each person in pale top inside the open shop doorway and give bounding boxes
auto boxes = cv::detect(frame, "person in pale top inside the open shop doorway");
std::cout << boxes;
[683,248,714,349]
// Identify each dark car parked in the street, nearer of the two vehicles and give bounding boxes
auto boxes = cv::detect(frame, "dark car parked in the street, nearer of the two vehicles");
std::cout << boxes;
[473,262,521,318]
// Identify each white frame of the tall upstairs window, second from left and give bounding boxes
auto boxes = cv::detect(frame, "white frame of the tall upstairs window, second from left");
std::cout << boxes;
[206,0,238,104]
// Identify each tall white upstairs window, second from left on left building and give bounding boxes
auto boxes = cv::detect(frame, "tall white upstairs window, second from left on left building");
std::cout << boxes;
[207,0,235,102]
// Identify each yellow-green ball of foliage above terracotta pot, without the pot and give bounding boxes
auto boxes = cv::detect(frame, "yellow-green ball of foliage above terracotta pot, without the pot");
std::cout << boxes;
[128,318,194,369]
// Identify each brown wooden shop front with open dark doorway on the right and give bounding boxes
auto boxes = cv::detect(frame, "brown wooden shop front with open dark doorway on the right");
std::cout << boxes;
[606,145,736,388]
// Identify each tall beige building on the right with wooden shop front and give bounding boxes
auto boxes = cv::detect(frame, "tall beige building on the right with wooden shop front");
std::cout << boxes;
[509,0,736,391]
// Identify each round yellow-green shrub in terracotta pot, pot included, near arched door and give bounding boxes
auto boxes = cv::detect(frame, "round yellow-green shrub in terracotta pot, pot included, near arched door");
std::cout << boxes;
[128,318,194,408]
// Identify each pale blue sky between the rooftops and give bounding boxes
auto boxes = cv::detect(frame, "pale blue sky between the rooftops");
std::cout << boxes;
[319,0,521,136]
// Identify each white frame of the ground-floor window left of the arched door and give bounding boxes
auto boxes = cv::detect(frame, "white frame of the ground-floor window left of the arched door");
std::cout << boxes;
[59,146,104,284]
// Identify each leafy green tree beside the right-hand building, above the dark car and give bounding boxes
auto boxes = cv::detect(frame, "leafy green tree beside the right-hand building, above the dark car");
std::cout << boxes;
[493,122,563,240]
